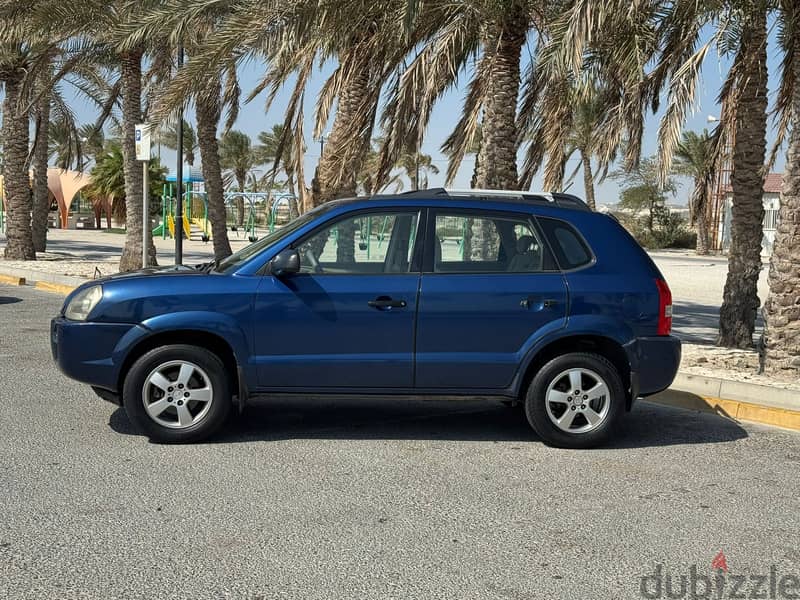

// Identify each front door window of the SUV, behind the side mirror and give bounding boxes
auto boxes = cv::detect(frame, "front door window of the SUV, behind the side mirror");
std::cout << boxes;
[297,212,418,275]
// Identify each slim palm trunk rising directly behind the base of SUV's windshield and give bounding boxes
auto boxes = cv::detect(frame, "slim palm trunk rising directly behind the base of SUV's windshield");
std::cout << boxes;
[195,74,232,260]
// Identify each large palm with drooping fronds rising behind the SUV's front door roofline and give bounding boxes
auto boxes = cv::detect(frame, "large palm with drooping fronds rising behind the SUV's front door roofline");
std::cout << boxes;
[133,0,452,216]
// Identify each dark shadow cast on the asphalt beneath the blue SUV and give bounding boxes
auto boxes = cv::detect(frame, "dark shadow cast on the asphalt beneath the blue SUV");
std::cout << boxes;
[109,398,747,448]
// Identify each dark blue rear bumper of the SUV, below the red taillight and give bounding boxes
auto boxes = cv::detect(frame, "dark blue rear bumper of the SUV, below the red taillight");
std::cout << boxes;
[625,335,681,399]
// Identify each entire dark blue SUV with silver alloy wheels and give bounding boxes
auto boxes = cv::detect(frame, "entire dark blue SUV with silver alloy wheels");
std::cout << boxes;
[51,190,681,448]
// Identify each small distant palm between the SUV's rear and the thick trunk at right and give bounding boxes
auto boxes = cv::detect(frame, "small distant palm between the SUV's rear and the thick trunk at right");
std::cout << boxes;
[674,129,716,255]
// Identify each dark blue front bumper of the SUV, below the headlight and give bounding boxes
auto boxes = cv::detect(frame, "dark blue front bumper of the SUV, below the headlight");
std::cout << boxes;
[50,317,136,392]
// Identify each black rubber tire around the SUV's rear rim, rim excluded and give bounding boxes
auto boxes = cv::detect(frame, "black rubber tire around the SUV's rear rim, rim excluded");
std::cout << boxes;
[525,352,626,448]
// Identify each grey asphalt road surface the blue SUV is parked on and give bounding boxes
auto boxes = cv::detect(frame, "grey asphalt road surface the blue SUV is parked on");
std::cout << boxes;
[0,285,800,600]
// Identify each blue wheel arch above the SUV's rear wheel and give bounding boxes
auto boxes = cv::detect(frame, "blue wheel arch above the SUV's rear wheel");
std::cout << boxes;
[516,334,633,410]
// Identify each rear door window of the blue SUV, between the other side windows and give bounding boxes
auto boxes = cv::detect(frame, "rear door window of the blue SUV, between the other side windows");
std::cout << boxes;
[433,212,554,273]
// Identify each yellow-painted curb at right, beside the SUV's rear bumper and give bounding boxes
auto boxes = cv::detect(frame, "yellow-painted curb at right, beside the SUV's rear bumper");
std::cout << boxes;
[646,373,800,431]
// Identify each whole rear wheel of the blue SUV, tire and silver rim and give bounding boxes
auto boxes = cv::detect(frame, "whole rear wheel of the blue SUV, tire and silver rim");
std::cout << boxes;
[525,352,625,448]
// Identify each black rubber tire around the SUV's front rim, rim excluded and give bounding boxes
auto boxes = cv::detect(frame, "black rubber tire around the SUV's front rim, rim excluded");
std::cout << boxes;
[122,344,231,443]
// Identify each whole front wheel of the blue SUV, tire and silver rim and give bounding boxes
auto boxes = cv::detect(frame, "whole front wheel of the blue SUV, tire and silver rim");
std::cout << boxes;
[122,344,231,444]
